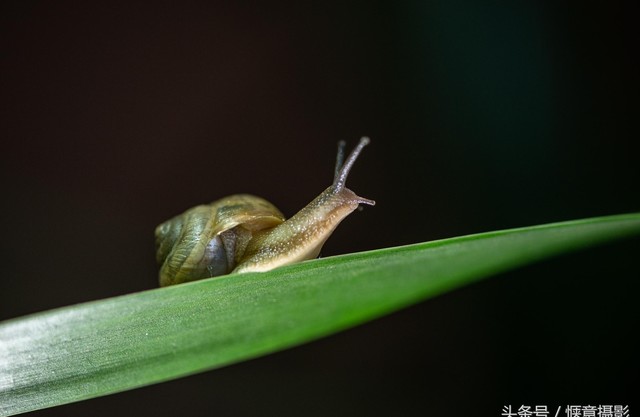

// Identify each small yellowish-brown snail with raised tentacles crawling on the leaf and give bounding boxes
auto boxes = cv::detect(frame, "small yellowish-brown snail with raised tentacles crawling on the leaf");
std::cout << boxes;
[155,137,375,286]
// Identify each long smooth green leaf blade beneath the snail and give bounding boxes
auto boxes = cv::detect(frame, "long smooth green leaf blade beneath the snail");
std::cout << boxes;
[0,213,640,415]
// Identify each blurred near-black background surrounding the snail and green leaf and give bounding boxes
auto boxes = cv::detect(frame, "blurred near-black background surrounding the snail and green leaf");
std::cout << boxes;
[0,0,640,416]
